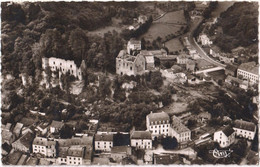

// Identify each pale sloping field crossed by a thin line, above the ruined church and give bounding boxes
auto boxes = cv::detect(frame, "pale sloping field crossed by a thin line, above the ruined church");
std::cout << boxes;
[142,10,186,41]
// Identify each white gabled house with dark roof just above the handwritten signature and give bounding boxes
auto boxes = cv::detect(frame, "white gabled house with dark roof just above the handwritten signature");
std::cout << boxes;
[213,126,235,148]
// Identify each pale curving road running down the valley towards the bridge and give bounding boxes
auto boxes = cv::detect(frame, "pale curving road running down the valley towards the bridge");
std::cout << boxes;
[188,18,226,67]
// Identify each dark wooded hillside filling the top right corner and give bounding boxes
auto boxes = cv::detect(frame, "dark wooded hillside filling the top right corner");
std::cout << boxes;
[213,2,258,53]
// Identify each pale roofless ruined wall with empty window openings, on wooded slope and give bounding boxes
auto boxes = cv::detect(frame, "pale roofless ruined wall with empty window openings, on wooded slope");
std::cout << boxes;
[42,57,86,80]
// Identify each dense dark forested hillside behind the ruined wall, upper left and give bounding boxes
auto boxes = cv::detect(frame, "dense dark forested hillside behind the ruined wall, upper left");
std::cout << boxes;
[1,2,142,77]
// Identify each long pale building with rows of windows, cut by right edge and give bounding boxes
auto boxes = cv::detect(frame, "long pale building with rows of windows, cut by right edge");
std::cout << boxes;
[237,62,259,84]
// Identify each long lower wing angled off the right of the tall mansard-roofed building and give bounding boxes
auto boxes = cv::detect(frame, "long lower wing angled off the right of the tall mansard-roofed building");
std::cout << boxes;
[171,116,191,143]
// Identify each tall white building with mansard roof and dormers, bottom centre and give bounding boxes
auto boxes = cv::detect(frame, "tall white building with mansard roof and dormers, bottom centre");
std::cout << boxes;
[146,112,170,139]
